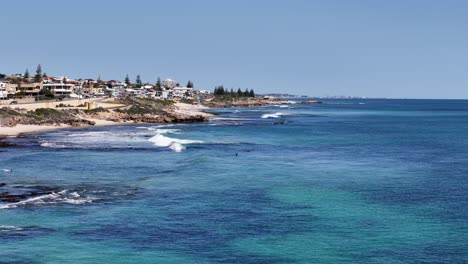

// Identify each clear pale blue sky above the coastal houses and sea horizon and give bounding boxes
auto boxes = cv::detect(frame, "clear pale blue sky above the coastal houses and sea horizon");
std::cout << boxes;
[0,0,468,98]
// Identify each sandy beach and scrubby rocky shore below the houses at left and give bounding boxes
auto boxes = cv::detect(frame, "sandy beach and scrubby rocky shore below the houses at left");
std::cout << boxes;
[0,99,210,136]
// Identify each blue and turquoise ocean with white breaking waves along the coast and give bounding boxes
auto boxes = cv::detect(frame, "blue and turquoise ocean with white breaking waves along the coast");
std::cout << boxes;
[0,100,468,263]
